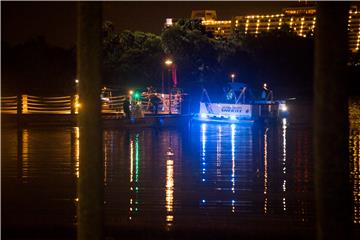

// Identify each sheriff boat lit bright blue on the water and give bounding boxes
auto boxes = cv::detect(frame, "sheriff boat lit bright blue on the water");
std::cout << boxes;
[193,83,287,123]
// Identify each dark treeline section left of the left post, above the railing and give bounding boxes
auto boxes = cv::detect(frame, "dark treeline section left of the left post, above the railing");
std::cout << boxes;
[1,37,76,95]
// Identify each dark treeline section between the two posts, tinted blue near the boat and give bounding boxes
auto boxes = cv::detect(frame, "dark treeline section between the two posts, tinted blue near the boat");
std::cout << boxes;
[104,19,313,98]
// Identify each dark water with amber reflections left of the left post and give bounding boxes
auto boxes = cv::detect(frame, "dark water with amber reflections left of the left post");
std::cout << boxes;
[1,128,76,227]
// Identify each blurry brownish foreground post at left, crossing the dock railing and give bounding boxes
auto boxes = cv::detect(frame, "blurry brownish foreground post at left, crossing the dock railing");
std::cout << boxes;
[77,2,104,240]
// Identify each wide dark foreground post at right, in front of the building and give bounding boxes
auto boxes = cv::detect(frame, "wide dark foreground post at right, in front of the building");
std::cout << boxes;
[314,2,352,239]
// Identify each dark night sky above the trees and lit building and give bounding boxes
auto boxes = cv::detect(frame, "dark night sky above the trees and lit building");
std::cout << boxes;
[1,1,298,47]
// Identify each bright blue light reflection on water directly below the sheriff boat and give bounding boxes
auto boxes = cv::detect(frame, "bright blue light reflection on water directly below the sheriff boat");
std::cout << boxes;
[198,123,256,213]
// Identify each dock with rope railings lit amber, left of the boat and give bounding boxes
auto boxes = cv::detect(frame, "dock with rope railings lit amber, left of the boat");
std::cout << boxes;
[1,94,192,128]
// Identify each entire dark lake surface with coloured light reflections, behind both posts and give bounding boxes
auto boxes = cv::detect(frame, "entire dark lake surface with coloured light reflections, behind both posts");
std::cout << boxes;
[1,102,360,237]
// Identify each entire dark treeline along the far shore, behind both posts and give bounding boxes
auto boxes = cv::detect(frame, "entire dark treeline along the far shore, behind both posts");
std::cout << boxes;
[2,19,360,98]
